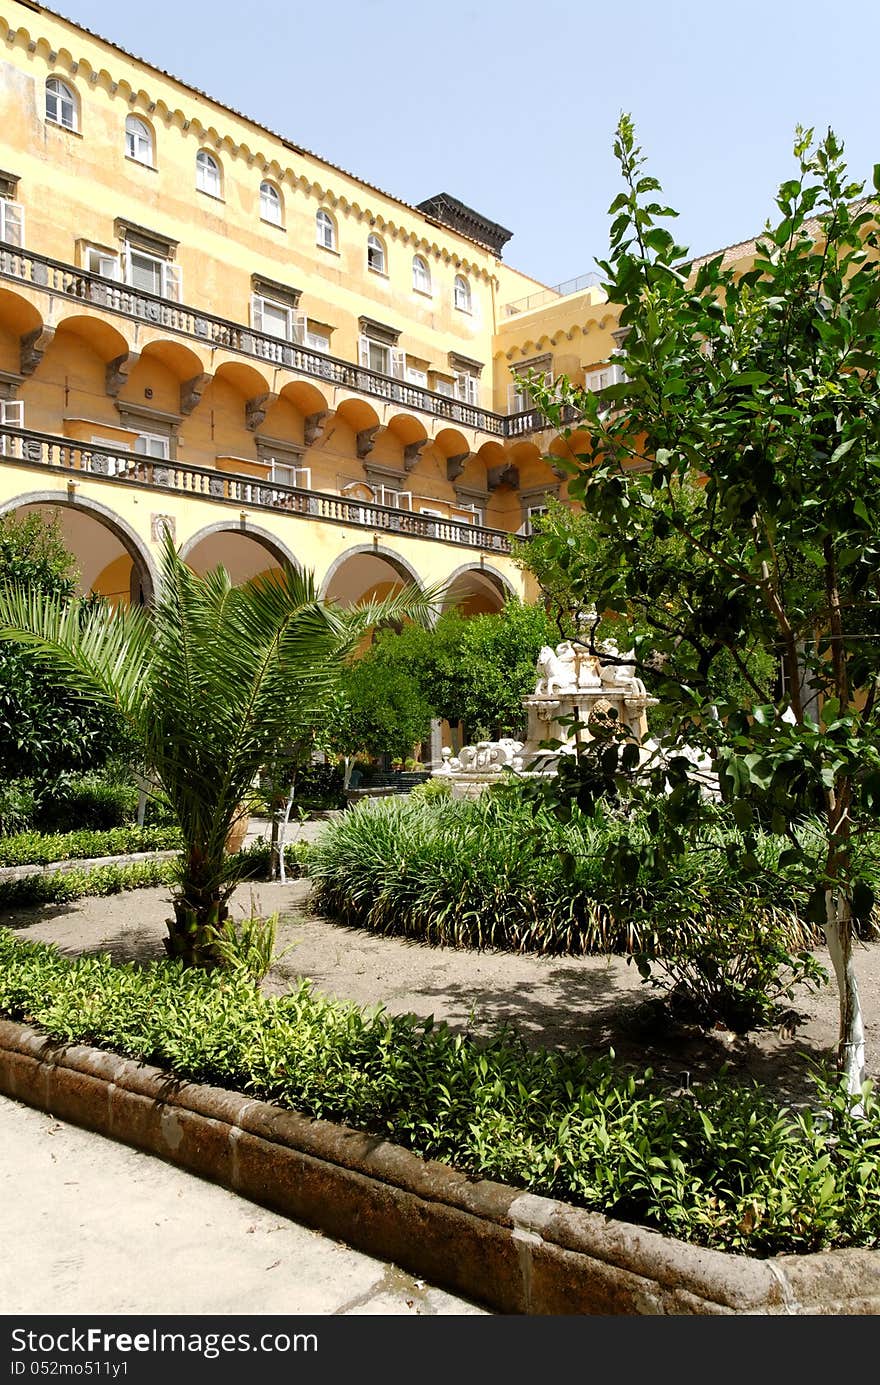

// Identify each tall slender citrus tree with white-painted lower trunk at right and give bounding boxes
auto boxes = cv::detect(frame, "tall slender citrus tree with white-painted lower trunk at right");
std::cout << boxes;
[526,116,880,1093]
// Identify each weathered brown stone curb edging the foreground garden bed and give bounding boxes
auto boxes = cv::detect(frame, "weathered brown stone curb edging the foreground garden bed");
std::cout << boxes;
[0,1019,880,1316]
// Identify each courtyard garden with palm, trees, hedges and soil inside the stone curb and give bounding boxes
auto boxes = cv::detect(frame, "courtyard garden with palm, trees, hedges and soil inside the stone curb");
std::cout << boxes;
[0,118,880,1274]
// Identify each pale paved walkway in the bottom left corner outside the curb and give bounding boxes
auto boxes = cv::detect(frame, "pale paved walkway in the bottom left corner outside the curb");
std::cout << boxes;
[0,1097,485,1317]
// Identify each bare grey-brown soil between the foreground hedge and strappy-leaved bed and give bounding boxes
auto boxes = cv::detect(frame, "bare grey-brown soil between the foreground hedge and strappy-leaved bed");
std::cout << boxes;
[0,825,880,1102]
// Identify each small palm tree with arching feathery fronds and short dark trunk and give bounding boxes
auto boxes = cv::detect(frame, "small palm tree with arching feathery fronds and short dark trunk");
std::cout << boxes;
[0,537,439,965]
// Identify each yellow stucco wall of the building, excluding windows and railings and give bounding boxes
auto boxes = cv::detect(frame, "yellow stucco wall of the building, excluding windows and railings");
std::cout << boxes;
[0,0,634,609]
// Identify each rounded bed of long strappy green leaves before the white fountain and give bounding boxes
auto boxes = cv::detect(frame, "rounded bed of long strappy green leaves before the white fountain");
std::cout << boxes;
[309,794,812,954]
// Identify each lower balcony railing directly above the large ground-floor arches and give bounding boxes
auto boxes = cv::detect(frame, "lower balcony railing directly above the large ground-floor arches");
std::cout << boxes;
[0,427,511,553]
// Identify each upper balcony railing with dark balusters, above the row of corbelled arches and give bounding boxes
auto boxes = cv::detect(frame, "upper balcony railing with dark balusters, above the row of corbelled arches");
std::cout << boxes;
[0,244,507,438]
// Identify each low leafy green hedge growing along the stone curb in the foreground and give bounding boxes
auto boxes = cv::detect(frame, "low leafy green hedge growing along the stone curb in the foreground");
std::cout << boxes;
[0,931,880,1255]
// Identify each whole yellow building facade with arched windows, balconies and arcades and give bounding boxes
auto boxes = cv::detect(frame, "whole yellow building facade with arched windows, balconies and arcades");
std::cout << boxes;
[0,0,626,614]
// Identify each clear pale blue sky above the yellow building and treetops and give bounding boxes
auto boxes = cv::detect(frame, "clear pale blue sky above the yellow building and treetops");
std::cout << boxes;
[54,0,880,284]
